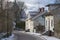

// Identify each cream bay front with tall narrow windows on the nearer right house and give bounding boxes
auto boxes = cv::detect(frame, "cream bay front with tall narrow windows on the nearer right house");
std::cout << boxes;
[45,16,54,32]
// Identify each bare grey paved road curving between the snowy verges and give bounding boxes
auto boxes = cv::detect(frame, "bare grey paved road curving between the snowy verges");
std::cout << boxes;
[14,32,46,40]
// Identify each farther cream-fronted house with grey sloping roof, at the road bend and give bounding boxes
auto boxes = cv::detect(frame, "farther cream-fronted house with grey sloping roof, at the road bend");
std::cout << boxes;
[25,8,45,32]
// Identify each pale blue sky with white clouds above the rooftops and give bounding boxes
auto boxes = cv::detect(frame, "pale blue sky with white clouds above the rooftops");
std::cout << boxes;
[10,0,55,11]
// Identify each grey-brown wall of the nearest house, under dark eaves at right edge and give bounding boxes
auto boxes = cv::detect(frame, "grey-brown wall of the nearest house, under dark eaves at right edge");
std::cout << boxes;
[47,3,60,37]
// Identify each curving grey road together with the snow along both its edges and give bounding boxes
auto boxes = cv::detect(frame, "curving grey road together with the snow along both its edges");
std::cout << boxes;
[2,31,60,40]
